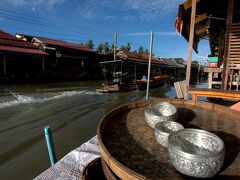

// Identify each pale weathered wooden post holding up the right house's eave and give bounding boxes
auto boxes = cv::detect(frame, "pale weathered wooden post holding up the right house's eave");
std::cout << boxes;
[186,0,196,93]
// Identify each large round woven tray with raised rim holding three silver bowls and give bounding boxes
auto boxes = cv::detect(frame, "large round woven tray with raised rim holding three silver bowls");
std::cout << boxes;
[97,99,240,179]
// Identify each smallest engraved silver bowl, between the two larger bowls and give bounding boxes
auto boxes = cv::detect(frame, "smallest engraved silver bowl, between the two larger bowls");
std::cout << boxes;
[154,121,184,147]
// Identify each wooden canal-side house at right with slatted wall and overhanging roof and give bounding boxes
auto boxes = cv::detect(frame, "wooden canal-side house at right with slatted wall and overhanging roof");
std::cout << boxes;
[175,0,240,100]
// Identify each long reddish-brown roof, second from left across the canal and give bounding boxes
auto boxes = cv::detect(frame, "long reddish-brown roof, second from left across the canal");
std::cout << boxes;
[36,37,94,52]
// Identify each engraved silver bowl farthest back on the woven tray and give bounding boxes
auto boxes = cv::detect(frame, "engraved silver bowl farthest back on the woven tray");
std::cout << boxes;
[144,102,177,129]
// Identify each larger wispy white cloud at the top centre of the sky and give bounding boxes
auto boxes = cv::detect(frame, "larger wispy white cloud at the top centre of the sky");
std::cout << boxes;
[79,0,184,20]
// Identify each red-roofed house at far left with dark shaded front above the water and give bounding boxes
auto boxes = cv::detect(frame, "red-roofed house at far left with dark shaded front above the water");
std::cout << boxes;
[0,30,48,83]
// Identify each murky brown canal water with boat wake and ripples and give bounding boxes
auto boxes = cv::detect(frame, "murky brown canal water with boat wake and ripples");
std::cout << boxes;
[0,81,207,180]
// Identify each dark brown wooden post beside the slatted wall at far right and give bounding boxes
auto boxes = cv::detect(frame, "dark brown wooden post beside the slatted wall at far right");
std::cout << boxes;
[222,0,233,90]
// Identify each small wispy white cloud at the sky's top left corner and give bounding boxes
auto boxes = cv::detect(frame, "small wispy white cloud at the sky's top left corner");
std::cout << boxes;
[6,0,66,11]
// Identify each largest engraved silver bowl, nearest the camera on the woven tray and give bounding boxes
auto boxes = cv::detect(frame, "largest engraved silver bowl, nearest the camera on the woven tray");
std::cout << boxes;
[168,129,225,178]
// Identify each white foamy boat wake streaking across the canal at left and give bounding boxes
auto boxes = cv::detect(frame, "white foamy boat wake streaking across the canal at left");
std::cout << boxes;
[0,91,102,109]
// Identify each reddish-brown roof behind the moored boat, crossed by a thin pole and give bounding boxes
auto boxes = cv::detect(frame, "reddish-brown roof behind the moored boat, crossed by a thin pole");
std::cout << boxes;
[117,51,165,64]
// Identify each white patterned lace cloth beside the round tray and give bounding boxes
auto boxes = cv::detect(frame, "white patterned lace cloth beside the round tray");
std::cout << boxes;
[34,136,100,180]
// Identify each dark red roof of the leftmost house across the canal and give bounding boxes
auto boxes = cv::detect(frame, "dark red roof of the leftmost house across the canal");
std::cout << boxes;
[0,30,47,55]
